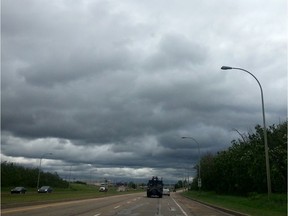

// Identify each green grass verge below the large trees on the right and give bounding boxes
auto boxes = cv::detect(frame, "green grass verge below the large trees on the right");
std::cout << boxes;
[183,191,287,216]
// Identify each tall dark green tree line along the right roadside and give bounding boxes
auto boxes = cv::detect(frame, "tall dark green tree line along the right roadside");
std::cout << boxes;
[191,121,287,195]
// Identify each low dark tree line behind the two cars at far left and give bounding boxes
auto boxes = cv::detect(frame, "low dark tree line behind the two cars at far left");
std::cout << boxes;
[1,161,69,188]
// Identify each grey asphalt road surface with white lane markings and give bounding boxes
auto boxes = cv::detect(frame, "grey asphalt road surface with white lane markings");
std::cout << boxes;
[1,193,235,216]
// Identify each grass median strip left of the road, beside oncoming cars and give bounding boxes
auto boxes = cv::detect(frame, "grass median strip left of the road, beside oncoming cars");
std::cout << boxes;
[1,184,143,208]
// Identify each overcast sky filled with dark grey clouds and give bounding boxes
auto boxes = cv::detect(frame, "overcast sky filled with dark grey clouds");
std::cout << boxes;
[1,0,287,182]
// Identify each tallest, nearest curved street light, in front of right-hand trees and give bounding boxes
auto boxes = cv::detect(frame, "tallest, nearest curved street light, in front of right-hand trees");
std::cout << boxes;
[221,66,271,197]
